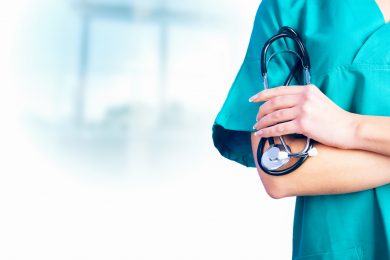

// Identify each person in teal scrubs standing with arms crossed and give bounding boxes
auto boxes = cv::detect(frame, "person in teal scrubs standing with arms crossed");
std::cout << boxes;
[212,0,390,260]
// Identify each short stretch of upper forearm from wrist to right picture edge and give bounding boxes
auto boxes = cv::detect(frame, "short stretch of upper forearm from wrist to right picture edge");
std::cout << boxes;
[351,115,390,156]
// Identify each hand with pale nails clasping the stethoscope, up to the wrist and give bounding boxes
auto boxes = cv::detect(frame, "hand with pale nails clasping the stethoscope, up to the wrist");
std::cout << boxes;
[249,85,356,149]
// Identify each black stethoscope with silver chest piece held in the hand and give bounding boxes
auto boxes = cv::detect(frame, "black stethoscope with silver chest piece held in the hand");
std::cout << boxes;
[257,26,317,176]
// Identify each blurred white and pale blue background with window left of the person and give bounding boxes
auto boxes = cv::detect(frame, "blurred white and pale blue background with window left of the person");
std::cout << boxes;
[0,0,295,260]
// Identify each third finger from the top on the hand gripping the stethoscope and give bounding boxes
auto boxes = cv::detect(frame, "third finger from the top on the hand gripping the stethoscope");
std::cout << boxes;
[254,107,299,130]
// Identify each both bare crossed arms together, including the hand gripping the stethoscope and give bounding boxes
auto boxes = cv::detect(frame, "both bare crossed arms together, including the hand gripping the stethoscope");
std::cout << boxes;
[251,86,390,198]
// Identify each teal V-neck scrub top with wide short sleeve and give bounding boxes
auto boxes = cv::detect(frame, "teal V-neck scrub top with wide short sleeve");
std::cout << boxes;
[212,0,390,260]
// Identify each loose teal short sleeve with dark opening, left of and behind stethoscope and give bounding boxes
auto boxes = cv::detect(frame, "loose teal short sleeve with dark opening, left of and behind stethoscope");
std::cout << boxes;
[212,0,302,167]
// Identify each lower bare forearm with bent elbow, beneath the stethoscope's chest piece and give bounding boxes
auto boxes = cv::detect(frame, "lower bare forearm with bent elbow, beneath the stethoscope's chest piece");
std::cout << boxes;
[251,134,390,198]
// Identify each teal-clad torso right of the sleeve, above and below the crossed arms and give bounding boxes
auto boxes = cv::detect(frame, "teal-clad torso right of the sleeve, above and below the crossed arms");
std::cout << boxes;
[291,0,390,260]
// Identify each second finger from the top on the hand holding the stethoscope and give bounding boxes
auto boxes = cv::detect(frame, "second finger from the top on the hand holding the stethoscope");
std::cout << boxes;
[256,95,301,121]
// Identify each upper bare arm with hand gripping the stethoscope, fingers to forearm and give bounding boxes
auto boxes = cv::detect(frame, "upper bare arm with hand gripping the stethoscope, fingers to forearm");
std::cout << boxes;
[251,85,390,156]
